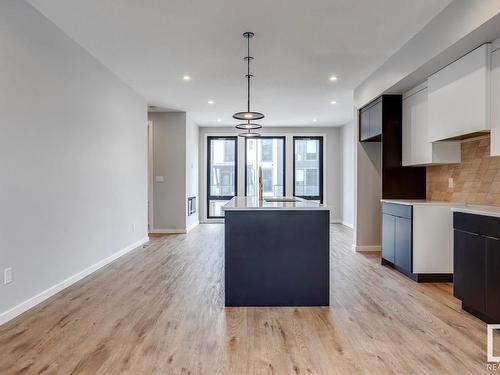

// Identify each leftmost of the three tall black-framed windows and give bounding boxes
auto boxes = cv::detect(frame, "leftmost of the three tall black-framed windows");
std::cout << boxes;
[207,137,237,218]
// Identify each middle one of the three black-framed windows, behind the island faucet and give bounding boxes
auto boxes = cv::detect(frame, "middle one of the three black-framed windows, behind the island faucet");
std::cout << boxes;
[245,137,285,197]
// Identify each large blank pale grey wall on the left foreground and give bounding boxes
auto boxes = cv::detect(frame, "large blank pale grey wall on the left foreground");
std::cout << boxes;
[0,0,147,323]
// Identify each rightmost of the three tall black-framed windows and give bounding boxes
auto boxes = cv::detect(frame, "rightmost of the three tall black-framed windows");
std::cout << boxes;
[293,137,323,202]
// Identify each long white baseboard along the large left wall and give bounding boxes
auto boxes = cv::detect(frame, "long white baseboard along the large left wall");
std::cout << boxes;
[0,237,149,325]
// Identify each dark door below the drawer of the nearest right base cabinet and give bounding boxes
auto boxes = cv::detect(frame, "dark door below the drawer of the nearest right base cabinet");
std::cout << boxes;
[453,229,486,313]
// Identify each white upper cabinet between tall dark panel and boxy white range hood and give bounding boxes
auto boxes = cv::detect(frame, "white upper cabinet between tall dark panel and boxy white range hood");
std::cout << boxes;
[403,82,461,166]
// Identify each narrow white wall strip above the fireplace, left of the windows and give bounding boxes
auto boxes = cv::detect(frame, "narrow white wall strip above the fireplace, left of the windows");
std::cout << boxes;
[186,116,200,230]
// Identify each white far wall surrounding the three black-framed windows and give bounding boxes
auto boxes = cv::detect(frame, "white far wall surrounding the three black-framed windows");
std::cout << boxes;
[199,127,342,222]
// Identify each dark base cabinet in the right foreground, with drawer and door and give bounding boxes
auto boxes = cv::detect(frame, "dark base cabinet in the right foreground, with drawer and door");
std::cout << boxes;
[453,212,500,324]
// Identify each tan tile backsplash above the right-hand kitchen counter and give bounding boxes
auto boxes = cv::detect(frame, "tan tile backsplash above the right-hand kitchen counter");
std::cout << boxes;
[427,137,500,205]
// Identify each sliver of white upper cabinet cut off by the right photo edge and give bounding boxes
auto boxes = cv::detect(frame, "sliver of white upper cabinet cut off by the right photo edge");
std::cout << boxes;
[490,39,500,156]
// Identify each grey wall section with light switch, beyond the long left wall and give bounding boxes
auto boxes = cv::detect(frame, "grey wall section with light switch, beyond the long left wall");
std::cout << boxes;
[148,112,187,232]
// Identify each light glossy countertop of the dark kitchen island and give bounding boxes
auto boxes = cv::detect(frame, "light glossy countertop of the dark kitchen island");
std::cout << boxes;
[222,196,330,211]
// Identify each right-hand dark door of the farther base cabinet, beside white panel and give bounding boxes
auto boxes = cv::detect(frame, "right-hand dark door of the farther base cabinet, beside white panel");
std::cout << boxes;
[394,216,412,276]
